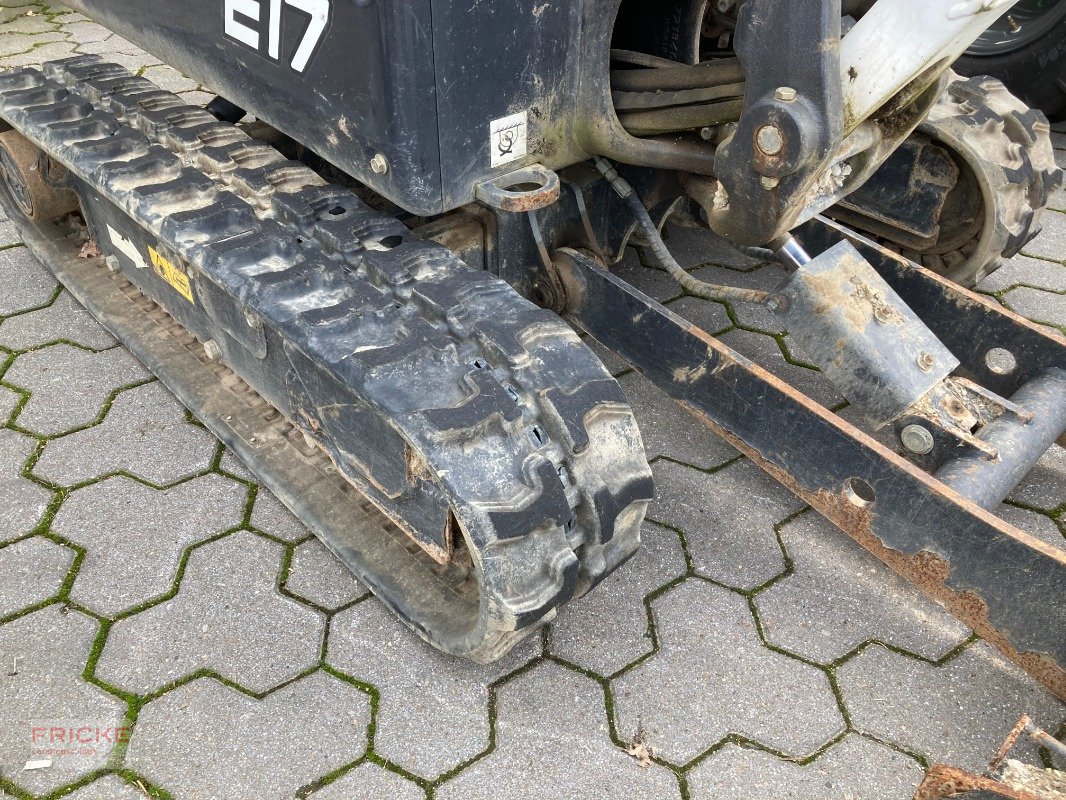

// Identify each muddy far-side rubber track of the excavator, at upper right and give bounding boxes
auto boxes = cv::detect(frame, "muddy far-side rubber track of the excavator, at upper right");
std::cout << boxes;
[904,76,1063,287]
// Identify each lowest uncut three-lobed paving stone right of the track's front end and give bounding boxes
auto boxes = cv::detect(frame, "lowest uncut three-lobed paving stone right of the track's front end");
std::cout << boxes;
[611,578,844,765]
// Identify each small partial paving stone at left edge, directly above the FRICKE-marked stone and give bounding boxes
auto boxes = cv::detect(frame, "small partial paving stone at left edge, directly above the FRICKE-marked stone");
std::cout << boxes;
[0,537,75,618]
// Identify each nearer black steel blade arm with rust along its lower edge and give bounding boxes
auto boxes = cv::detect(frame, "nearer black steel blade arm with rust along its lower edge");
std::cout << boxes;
[567,252,1066,698]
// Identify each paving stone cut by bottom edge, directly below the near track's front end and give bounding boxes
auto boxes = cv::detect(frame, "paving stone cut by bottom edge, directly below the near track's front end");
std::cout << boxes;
[435,663,680,800]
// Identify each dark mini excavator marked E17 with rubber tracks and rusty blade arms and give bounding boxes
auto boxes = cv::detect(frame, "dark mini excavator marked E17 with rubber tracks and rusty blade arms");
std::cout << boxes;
[0,0,1066,697]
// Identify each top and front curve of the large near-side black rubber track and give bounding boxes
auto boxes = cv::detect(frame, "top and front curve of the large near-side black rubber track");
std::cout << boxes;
[0,57,651,660]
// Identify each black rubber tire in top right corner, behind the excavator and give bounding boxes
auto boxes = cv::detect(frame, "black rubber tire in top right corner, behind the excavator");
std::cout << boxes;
[953,0,1066,122]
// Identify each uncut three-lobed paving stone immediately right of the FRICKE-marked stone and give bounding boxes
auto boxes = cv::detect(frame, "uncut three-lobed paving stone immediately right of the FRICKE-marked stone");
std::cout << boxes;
[96,531,325,694]
